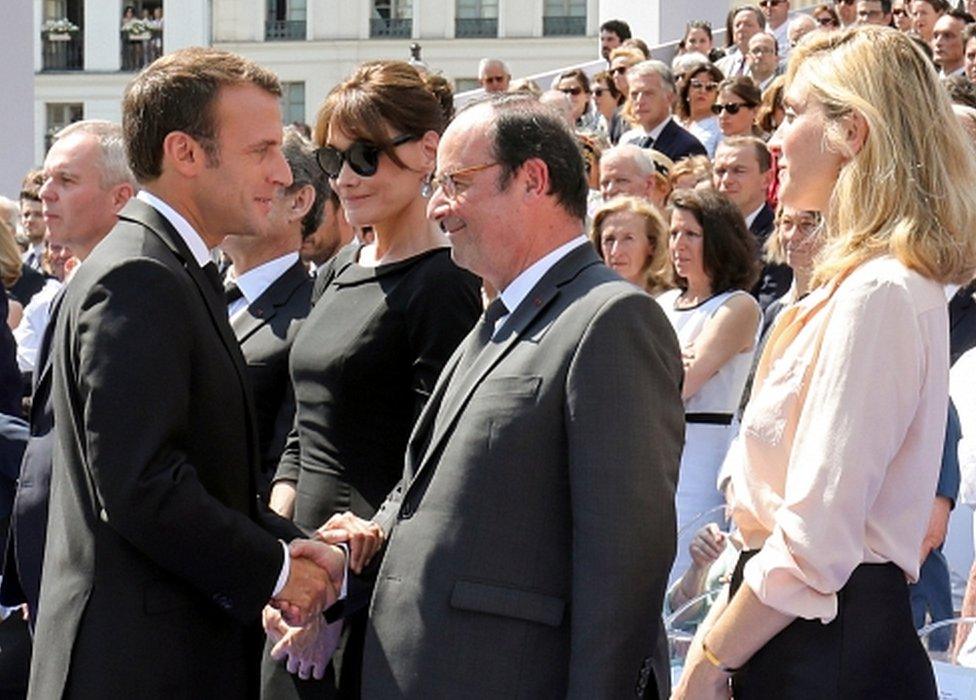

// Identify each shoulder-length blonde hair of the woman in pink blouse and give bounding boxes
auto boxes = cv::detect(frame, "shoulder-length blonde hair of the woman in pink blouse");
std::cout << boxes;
[786,27,976,286]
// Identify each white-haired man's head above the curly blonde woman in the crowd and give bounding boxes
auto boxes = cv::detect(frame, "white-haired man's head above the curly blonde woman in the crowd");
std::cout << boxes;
[600,144,674,209]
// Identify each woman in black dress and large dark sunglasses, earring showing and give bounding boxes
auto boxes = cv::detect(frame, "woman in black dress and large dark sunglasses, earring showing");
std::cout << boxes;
[262,61,481,698]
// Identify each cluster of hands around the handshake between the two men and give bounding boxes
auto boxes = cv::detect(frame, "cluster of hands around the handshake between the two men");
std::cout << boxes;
[263,512,383,679]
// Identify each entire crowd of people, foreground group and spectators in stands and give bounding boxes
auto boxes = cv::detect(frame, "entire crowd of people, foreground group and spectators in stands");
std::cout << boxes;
[0,0,976,700]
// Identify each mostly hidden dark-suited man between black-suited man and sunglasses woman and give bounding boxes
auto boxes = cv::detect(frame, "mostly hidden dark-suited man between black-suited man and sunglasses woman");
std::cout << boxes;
[221,128,318,500]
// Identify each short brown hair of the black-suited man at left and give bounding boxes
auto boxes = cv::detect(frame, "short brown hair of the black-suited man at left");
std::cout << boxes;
[122,47,281,182]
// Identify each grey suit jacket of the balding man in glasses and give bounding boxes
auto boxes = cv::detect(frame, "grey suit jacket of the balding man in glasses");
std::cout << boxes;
[363,245,684,699]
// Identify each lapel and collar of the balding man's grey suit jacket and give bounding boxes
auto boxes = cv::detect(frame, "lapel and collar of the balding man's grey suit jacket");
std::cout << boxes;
[406,244,600,492]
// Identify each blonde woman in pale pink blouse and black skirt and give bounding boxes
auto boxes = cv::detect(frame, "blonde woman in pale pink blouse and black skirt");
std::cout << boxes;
[674,27,976,700]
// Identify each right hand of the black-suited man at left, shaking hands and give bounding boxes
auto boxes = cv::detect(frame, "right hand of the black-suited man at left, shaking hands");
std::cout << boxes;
[271,540,346,625]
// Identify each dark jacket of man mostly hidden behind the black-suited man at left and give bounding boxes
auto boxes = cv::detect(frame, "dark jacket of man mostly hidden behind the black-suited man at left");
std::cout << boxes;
[231,260,312,496]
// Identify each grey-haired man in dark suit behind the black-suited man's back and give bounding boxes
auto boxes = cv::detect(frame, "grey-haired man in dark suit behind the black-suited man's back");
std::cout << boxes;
[0,120,136,626]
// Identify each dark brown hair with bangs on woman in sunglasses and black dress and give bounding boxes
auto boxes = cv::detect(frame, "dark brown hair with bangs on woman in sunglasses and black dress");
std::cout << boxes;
[315,61,446,168]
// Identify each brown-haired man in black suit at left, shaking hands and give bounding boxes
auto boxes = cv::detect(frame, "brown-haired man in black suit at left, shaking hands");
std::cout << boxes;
[30,49,344,698]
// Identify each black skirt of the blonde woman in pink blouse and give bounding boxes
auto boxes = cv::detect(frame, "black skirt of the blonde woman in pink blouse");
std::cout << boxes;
[730,550,938,700]
